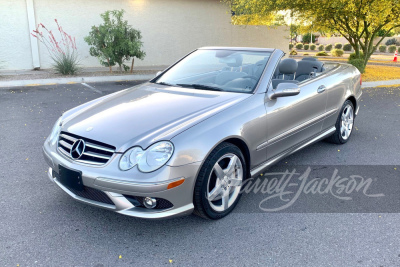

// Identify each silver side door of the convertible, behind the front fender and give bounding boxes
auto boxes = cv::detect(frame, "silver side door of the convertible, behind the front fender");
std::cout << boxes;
[265,78,328,159]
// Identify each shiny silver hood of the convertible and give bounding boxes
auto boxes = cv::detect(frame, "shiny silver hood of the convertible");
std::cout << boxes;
[62,83,250,152]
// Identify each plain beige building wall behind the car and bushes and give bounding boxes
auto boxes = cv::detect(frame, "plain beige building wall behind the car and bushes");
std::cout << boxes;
[0,0,288,70]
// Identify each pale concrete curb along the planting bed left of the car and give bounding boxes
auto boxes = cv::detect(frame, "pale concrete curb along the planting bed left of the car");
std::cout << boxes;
[0,74,155,90]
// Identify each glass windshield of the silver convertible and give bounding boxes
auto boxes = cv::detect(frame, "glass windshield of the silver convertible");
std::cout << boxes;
[155,49,271,93]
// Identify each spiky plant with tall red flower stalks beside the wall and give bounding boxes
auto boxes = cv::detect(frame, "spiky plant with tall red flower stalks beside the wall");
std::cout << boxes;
[31,19,79,75]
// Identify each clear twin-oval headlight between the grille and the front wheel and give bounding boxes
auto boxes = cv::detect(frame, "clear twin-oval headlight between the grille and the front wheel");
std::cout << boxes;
[119,141,174,172]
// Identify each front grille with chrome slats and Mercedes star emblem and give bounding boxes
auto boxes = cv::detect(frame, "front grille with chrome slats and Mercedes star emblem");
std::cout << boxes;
[58,132,115,165]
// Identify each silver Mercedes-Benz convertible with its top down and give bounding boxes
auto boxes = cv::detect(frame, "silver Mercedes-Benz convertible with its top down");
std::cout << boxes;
[43,47,361,219]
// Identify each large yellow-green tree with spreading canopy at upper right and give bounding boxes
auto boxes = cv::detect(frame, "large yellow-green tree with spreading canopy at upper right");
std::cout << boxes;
[224,0,400,70]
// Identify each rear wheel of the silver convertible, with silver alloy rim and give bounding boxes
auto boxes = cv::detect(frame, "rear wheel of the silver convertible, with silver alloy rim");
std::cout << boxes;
[326,100,355,145]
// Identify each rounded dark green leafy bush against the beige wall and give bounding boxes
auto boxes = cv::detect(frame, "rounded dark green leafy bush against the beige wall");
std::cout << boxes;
[85,10,146,73]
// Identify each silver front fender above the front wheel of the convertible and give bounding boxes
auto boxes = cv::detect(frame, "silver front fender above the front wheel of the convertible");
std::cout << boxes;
[169,94,267,170]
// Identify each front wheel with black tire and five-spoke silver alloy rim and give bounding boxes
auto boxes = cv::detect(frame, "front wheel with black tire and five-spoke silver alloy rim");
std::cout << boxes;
[193,143,247,220]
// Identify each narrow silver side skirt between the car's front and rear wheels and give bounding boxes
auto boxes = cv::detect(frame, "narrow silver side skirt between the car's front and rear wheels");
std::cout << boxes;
[250,126,336,177]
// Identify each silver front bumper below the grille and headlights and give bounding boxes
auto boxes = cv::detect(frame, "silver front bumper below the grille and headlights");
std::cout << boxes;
[43,142,200,219]
